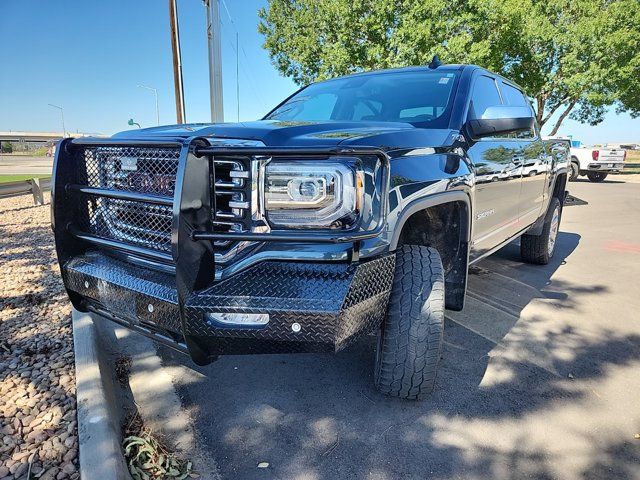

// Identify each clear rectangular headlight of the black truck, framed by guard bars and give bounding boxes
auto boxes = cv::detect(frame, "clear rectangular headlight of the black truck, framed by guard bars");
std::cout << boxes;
[264,161,363,228]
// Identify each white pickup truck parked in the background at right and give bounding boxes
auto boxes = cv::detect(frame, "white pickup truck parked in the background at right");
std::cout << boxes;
[569,147,627,182]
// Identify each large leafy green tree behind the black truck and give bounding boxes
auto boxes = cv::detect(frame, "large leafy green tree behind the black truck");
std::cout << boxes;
[258,0,640,135]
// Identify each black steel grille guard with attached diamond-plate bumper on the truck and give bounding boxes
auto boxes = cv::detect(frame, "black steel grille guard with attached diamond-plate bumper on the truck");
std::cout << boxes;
[51,138,395,364]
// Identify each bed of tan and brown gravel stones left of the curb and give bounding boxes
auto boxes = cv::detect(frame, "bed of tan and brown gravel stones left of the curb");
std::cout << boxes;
[0,195,79,480]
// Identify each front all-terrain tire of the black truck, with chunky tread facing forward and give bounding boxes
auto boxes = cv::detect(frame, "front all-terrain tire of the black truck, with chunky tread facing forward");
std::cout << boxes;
[375,245,444,400]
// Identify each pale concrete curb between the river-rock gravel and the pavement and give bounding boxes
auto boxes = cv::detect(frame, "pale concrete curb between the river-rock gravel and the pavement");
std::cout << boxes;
[72,309,131,480]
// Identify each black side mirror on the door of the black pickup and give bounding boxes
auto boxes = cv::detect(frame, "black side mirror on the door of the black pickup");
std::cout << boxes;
[466,105,535,140]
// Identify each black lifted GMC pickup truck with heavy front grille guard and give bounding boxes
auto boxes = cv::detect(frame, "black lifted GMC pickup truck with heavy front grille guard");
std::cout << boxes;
[52,63,568,398]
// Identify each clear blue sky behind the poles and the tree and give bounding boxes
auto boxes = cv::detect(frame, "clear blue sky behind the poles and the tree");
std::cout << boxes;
[0,0,640,144]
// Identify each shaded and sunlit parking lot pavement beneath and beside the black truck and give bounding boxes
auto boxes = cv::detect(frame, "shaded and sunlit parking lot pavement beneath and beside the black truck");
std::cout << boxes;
[155,177,640,480]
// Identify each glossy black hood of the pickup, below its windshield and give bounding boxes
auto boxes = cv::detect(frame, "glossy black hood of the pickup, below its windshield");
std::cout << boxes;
[114,120,453,150]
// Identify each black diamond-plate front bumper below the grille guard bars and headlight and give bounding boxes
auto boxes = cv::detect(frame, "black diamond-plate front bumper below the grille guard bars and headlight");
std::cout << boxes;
[62,251,395,364]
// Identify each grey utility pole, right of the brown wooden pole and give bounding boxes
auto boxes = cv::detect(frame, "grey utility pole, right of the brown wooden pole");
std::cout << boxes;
[204,0,224,123]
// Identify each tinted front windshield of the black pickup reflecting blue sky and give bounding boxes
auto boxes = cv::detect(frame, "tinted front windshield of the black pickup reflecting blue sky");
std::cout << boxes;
[265,71,457,128]
